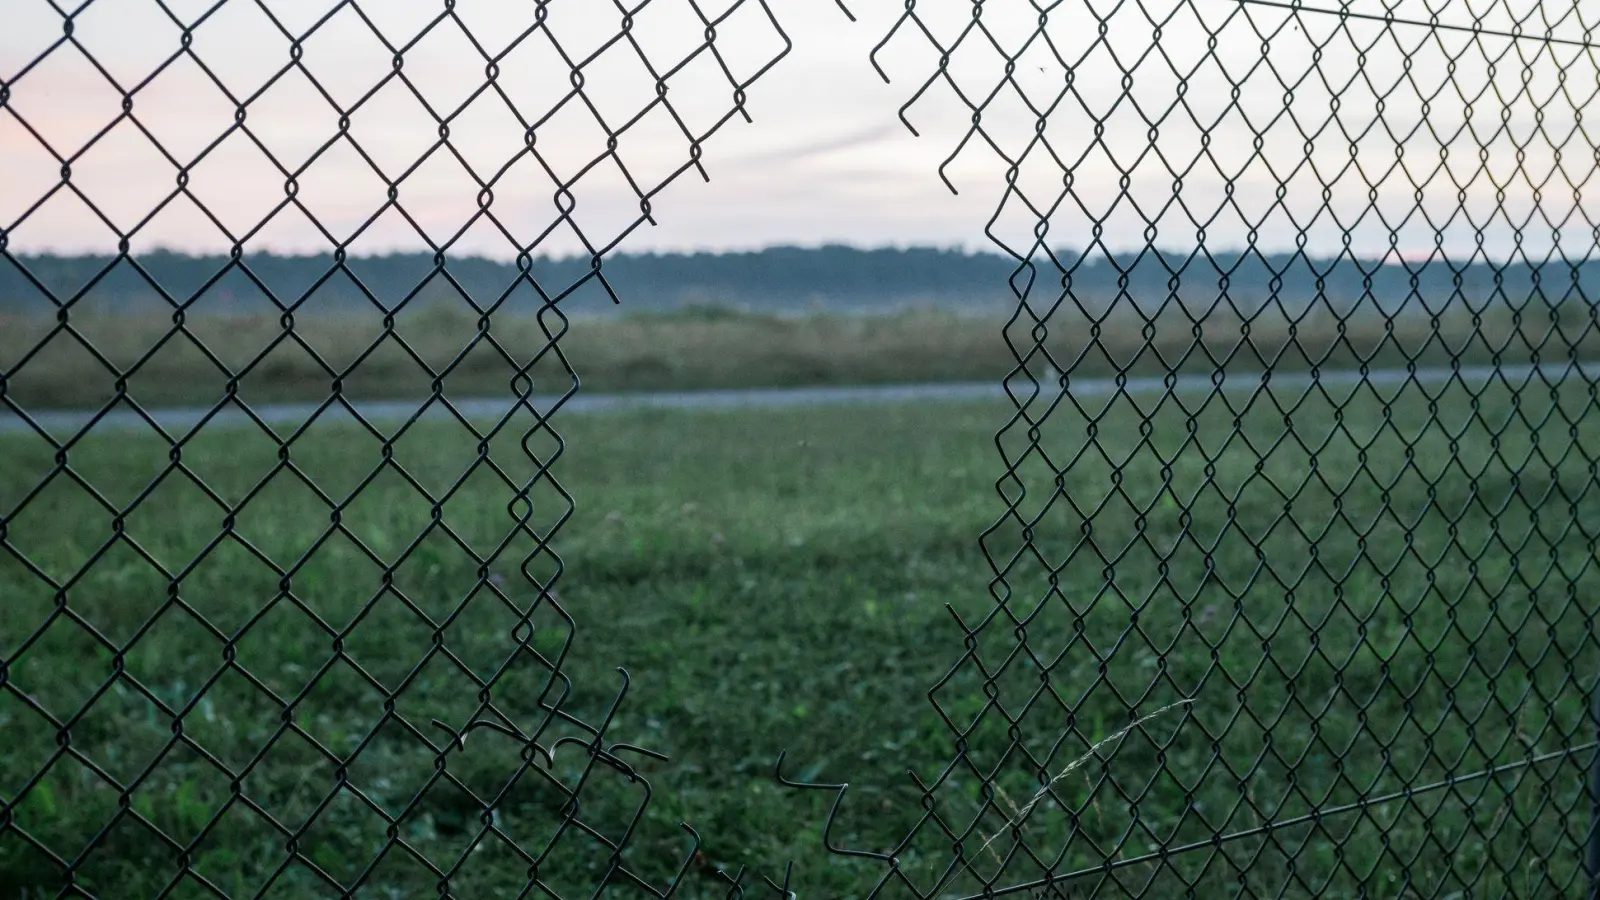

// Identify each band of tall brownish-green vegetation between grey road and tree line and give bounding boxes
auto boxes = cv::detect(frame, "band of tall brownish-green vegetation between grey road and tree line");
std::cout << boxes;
[0,303,1600,410]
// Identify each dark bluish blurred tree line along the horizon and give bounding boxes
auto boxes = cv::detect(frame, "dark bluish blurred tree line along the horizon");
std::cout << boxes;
[0,247,1600,312]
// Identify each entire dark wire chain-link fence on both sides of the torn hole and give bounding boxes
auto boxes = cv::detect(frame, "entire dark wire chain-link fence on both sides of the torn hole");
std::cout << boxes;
[0,0,1600,898]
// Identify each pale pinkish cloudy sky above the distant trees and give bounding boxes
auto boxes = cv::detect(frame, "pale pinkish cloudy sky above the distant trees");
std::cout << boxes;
[0,0,1600,258]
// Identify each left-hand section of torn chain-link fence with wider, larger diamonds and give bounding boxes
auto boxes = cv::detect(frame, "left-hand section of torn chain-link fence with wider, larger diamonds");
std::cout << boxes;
[0,0,789,897]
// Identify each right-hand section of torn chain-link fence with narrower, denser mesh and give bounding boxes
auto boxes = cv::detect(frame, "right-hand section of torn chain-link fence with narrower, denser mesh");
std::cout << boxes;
[755,0,1600,898]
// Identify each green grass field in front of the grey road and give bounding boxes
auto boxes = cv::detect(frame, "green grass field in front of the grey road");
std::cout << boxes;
[0,369,1600,898]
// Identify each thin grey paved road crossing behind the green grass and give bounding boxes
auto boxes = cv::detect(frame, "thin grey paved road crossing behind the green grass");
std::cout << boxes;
[0,362,1600,437]
